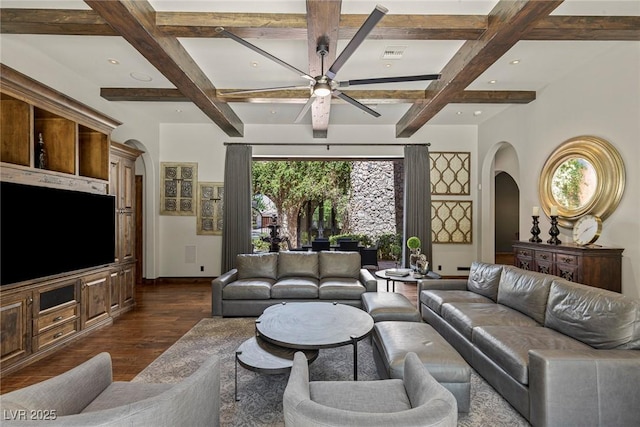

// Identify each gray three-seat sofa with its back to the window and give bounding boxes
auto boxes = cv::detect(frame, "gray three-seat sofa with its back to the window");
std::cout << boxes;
[211,251,378,316]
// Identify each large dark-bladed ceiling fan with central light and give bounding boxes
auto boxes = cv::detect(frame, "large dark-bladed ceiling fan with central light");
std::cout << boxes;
[216,5,440,123]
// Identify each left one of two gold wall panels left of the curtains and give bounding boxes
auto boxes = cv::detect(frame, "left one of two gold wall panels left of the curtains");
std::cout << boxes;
[160,162,198,216]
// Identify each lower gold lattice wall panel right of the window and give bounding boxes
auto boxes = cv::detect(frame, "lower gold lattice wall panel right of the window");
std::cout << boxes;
[431,200,473,244]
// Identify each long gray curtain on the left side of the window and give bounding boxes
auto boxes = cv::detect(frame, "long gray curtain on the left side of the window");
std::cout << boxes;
[221,144,252,273]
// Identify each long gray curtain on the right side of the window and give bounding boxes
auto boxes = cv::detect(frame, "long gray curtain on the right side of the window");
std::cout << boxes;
[402,144,433,270]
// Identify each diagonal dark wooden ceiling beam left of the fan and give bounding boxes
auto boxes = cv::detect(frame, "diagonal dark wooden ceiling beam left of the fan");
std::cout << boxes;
[85,0,244,136]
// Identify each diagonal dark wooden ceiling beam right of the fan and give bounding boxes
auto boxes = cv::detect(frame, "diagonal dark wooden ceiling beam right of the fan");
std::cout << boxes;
[396,0,563,138]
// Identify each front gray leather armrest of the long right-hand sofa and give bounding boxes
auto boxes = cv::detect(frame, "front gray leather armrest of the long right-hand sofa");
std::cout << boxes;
[529,349,640,426]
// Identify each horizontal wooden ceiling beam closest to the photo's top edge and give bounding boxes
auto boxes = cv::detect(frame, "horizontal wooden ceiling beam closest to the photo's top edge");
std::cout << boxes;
[0,8,640,41]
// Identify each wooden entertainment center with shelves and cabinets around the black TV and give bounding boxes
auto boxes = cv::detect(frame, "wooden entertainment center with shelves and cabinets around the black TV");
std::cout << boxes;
[0,64,142,375]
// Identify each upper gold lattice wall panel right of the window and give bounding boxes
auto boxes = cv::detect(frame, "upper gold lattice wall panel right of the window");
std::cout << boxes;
[429,151,471,196]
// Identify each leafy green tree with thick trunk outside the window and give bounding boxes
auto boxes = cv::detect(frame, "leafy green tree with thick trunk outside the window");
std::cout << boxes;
[252,161,351,247]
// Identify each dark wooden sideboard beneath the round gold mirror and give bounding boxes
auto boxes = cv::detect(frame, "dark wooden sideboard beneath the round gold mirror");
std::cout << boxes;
[513,242,624,292]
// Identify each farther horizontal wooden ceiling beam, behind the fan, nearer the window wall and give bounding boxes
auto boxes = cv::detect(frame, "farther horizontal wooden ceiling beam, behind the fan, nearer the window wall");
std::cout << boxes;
[100,88,536,104]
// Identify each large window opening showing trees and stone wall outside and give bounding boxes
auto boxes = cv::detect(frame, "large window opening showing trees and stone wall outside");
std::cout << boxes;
[252,159,404,259]
